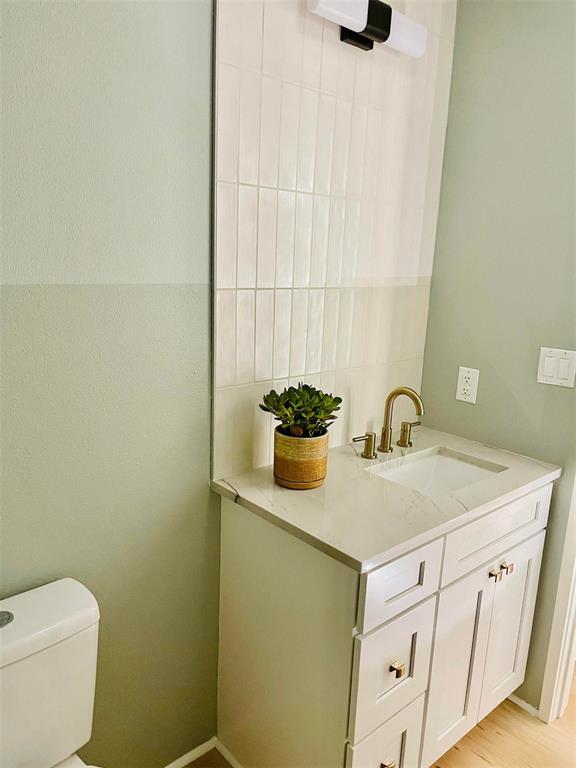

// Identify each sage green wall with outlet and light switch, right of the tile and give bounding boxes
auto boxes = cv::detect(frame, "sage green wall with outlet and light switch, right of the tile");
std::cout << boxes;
[423,0,576,705]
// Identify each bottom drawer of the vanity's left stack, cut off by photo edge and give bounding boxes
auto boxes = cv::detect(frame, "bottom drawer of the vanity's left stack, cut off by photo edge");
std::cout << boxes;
[346,695,424,768]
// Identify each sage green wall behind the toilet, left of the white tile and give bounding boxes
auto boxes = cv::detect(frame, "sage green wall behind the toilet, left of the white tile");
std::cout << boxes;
[1,0,219,768]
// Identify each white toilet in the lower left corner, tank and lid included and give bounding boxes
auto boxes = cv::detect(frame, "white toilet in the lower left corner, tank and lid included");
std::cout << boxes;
[0,579,100,768]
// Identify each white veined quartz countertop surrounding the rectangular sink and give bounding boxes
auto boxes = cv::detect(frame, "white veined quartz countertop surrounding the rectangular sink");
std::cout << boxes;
[212,427,561,572]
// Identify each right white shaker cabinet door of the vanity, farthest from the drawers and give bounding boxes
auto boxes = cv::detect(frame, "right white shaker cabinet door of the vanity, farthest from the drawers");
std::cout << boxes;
[479,531,545,719]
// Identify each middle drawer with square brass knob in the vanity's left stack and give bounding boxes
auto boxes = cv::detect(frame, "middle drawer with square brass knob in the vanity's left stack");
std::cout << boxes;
[348,596,436,744]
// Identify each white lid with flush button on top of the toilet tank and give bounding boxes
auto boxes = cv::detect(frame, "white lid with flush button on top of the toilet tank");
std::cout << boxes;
[0,579,100,668]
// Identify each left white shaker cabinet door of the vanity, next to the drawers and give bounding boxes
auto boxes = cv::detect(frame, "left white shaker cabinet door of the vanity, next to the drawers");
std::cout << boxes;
[422,567,495,766]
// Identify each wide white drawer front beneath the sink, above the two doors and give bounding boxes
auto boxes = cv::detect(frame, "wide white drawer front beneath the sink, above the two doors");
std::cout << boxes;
[442,483,552,587]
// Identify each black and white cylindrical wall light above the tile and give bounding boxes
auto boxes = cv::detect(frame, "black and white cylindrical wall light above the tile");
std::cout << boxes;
[308,0,428,59]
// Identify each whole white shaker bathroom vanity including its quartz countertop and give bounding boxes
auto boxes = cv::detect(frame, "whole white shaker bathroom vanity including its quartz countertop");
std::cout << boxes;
[214,429,560,768]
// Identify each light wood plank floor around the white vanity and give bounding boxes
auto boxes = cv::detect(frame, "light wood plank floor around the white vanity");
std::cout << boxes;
[193,679,576,768]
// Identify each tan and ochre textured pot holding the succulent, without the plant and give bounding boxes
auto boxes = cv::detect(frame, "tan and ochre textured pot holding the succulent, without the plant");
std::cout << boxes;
[274,427,328,491]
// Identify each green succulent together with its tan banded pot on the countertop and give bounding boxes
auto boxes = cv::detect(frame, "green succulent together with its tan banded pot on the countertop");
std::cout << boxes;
[260,384,342,490]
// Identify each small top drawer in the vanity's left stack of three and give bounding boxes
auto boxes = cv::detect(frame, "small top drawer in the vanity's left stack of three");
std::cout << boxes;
[358,539,442,632]
